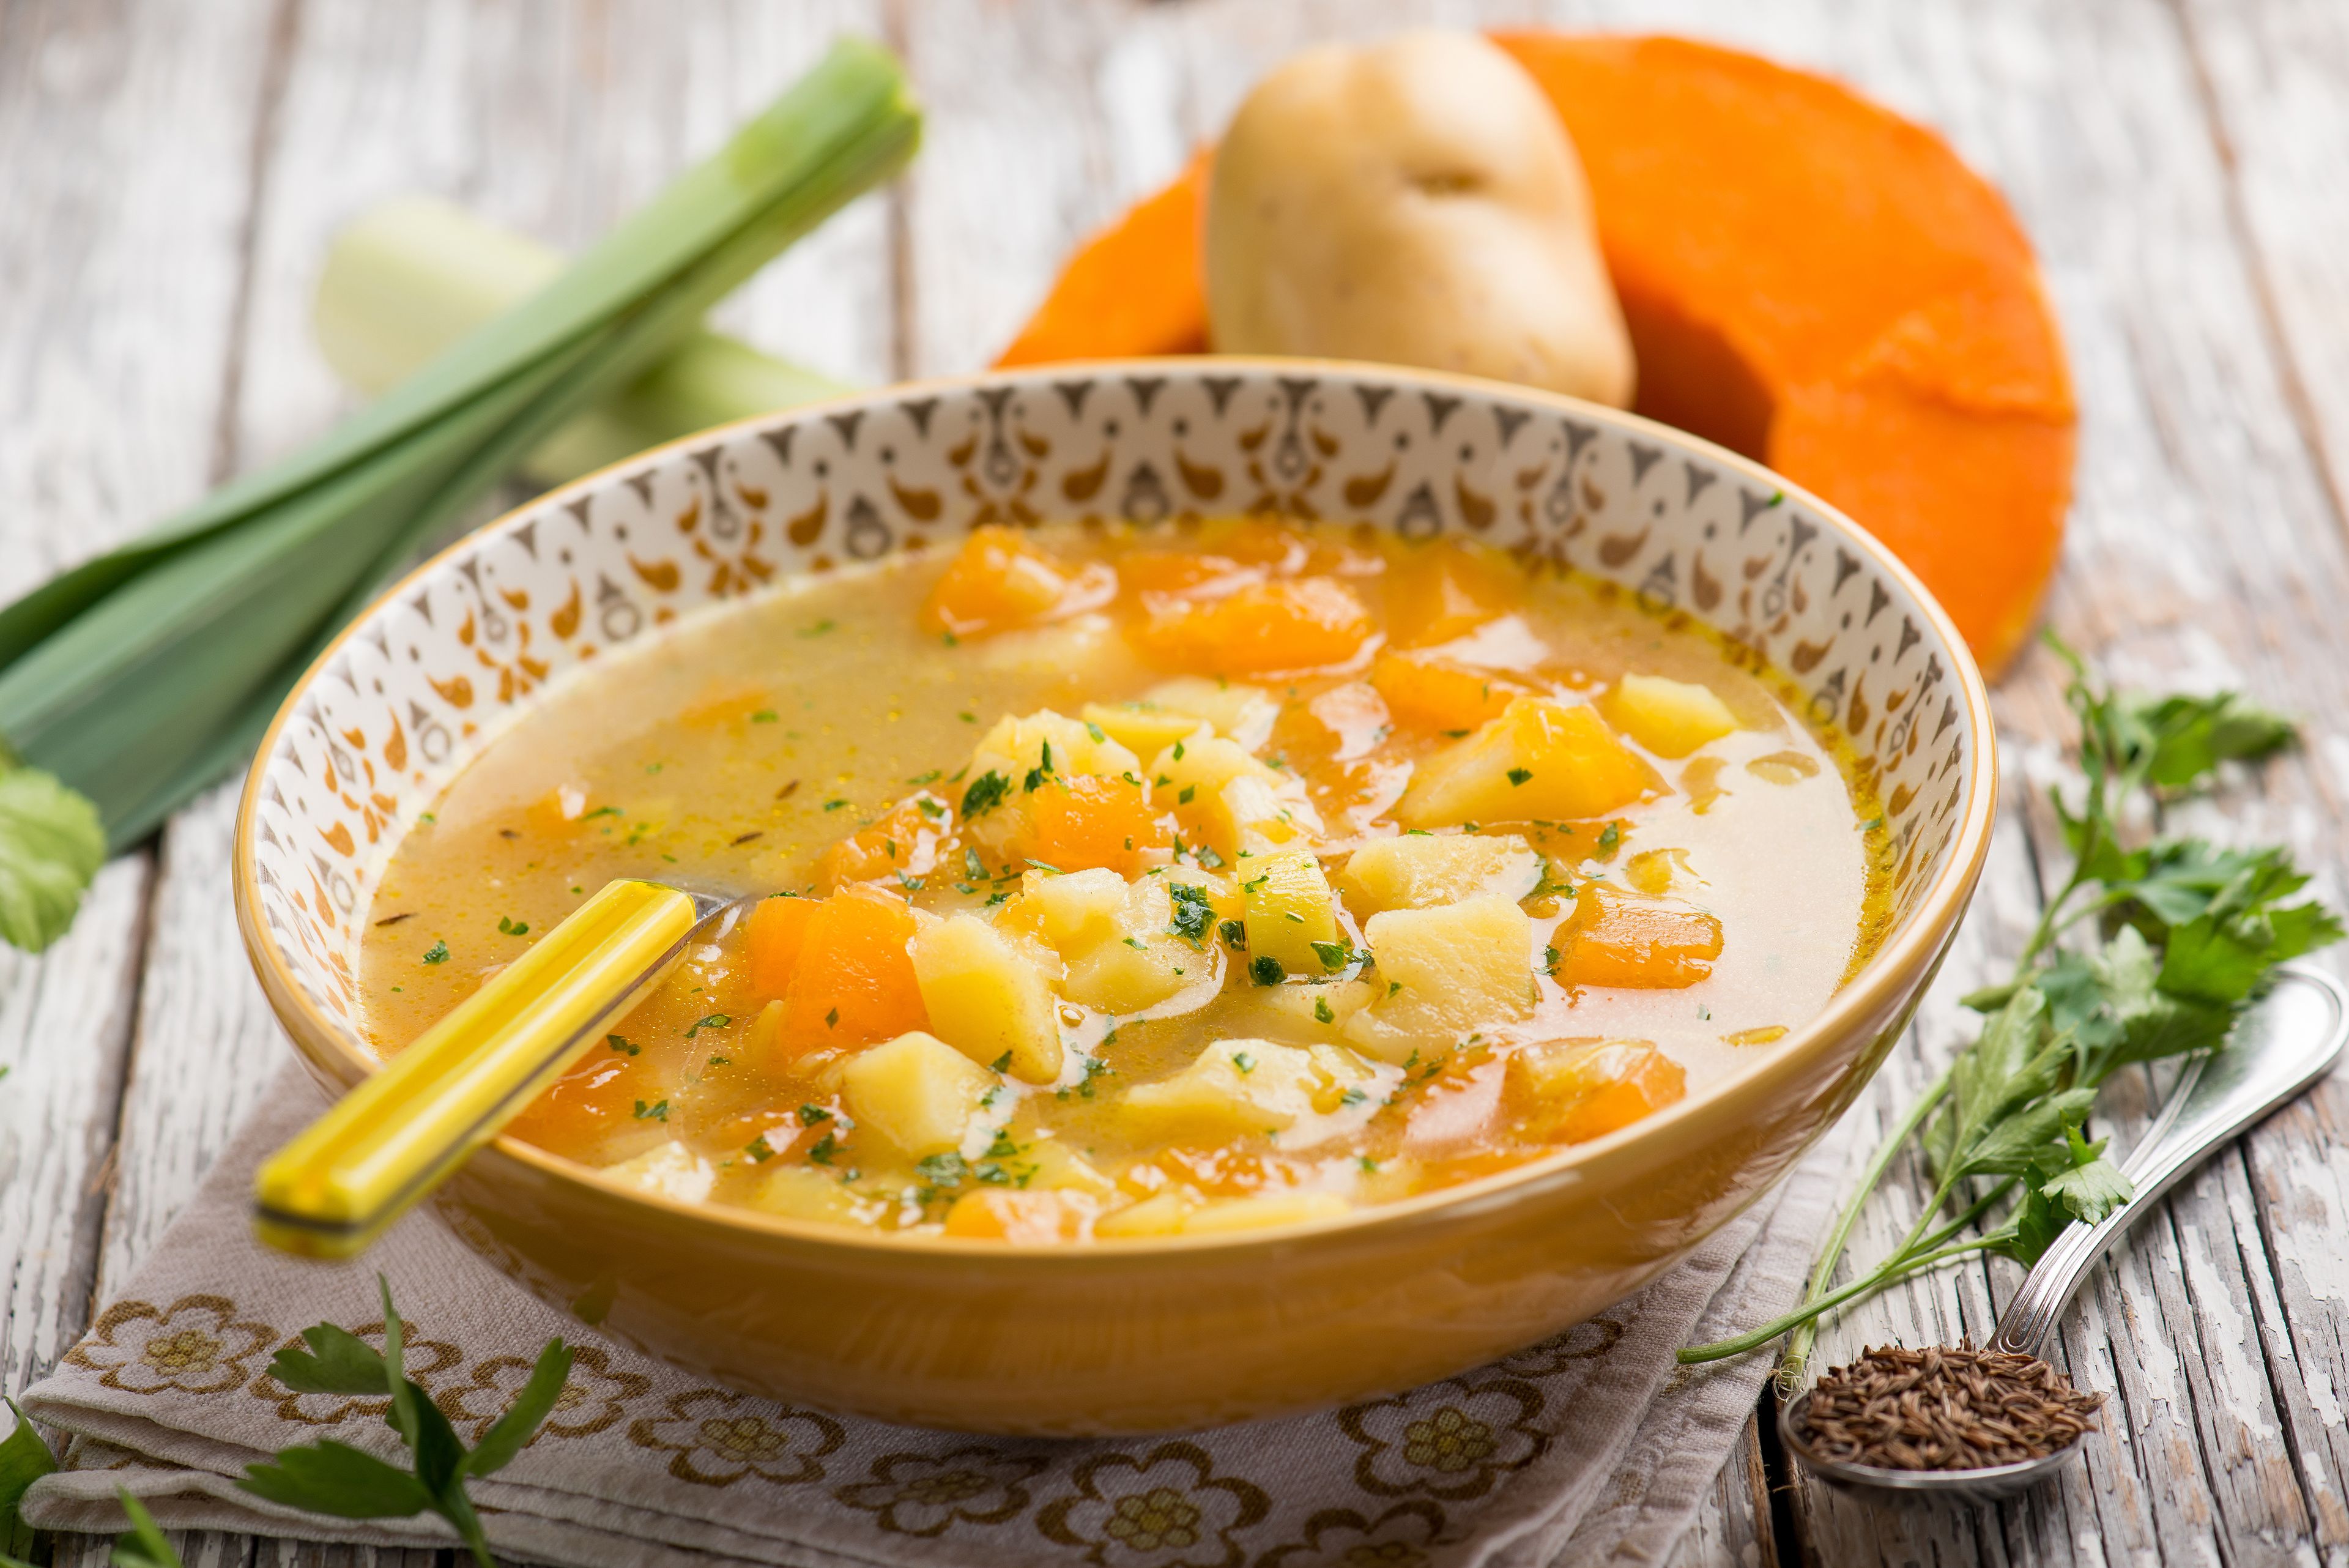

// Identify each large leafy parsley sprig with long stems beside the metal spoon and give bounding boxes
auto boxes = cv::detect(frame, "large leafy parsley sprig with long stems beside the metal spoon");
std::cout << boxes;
[1680,637,2342,1384]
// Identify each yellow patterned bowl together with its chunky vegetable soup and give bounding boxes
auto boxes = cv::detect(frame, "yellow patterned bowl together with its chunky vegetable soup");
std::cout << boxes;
[237,360,1994,1434]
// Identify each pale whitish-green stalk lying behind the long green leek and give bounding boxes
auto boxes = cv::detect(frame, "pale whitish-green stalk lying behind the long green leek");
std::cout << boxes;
[310,195,853,485]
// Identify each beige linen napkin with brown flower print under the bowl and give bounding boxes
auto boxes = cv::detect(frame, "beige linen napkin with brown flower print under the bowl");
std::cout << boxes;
[23,1068,1849,1568]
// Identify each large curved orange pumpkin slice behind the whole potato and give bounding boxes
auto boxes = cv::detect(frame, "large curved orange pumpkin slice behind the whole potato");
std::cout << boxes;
[998,33,2077,675]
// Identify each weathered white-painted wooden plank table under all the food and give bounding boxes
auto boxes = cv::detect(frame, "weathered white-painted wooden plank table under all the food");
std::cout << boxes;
[0,0,2349,1566]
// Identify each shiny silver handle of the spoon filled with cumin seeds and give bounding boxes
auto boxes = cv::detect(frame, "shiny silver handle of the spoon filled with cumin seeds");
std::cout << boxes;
[1989,964,2349,1356]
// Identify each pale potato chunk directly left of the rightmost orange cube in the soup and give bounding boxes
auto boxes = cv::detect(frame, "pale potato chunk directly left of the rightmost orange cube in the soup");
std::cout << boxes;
[1346,893,1534,1063]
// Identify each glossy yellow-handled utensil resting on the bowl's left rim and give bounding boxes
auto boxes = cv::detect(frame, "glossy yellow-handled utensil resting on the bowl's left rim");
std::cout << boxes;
[254,879,754,1258]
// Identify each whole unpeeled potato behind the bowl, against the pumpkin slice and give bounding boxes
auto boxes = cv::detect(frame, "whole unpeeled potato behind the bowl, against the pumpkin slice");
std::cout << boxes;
[1208,31,1635,407]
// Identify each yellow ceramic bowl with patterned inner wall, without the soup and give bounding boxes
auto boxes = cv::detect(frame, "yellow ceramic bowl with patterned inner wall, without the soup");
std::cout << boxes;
[235,360,1994,1434]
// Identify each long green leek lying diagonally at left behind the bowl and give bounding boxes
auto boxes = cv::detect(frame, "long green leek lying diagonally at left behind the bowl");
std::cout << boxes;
[0,40,921,948]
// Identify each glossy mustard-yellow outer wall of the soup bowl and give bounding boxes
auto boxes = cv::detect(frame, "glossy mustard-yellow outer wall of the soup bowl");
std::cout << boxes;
[235,362,1997,1436]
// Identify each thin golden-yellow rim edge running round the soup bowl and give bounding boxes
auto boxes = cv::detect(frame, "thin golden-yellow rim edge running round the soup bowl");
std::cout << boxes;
[230,355,1999,1267]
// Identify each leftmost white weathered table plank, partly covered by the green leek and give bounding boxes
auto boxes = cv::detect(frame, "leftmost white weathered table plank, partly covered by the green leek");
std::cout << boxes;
[0,0,272,1392]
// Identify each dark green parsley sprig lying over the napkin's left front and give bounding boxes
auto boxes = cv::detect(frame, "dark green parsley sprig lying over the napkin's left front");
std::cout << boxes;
[237,1277,571,1568]
